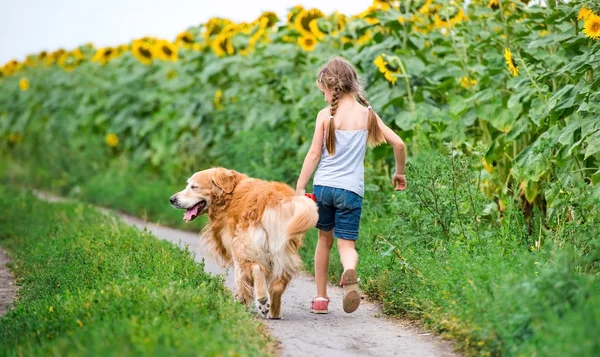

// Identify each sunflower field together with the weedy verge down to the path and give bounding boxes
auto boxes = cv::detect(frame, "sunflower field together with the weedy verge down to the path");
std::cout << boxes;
[0,0,600,356]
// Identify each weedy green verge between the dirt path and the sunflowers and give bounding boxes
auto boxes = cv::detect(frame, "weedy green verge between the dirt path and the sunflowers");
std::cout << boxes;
[2,153,600,356]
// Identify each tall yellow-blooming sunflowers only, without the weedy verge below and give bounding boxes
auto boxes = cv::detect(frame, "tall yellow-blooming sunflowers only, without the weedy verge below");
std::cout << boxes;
[0,0,600,213]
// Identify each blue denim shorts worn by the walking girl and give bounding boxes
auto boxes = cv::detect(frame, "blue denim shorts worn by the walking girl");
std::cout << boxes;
[314,185,362,240]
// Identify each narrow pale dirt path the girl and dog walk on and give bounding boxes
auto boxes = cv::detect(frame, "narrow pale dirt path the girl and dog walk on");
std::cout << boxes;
[121,215,456,357]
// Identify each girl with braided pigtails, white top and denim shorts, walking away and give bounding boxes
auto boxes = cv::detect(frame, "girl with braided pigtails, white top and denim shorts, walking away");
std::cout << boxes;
[296,57,406,314]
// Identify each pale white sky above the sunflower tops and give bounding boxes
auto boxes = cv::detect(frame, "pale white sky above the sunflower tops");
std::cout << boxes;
[0,0,372,66]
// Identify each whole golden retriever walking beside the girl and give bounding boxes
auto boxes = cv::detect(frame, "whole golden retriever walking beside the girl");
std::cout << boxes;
[170,168,318,319]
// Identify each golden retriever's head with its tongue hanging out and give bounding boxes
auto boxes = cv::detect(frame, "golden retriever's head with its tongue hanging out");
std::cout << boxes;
[170,167,240,221]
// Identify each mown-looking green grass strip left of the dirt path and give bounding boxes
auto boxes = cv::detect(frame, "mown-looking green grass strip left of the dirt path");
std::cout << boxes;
[0,186,271,356]
